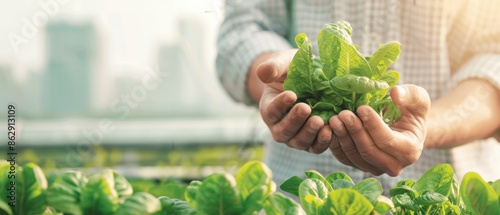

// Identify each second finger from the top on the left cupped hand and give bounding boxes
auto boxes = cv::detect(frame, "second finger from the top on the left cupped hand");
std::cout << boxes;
[270,103,311,144]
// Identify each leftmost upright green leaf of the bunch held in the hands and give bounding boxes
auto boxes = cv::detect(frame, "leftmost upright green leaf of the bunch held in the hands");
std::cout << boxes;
[283,33,321,98]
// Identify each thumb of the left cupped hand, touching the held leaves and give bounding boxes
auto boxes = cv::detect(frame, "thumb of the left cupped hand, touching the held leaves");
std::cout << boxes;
[257,50,297,83]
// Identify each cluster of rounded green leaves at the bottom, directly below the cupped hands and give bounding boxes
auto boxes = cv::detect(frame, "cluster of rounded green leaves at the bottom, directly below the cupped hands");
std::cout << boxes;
[280,170,392,215]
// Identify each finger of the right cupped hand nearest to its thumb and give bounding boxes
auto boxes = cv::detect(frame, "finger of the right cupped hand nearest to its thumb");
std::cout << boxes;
[357,106,420,167]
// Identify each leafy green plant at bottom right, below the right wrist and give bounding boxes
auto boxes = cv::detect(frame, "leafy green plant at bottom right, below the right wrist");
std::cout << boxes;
[389,164,468,215]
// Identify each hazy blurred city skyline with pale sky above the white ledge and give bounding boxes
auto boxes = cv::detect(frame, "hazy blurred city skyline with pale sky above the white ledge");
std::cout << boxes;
[0,0,258,118]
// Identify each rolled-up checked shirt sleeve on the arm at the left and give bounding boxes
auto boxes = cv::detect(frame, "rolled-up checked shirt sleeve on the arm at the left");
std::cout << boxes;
[216,0,291,105]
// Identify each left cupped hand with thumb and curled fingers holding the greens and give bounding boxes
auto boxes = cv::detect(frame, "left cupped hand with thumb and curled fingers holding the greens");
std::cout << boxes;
[256,50,332,154]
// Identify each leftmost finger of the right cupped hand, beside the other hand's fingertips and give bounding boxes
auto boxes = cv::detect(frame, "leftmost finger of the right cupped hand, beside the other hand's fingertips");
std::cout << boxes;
[330,111,383,175]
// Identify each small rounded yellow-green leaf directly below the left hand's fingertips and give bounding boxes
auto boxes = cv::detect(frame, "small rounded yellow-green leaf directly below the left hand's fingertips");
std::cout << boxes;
[299,178,328,215]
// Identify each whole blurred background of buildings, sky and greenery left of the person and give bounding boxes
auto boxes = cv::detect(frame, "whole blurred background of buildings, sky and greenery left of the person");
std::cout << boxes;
[0,0,267,180]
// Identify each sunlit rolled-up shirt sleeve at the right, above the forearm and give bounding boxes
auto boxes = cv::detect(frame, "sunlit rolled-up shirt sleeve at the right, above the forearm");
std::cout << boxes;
[448,0,500,141]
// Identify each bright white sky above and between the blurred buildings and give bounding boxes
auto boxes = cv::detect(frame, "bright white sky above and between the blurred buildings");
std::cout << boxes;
[0,0,221,80]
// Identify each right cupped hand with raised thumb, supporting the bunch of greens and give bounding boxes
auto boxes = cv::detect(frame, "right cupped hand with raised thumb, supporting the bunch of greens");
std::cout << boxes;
[329,85,430,176]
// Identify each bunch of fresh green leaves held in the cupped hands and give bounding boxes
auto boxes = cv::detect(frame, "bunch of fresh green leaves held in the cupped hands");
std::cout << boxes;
[283,21,401,124]
